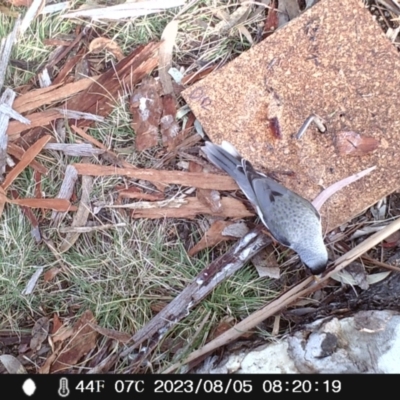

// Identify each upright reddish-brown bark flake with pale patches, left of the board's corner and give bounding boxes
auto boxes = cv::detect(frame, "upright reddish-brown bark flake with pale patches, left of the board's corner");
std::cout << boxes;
[130,76,162,151]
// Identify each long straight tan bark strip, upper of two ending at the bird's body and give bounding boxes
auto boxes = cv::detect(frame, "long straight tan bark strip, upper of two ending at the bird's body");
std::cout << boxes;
[73,163,238,190]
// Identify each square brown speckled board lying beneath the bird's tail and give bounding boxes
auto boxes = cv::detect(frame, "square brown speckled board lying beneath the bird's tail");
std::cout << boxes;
[183,0,400,231]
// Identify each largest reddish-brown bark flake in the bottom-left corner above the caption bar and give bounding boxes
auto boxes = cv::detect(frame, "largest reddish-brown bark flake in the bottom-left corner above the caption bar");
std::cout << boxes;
[51,310,98,373]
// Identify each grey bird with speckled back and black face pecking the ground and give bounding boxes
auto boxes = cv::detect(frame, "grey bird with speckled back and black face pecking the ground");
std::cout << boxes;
[202,141,328,275]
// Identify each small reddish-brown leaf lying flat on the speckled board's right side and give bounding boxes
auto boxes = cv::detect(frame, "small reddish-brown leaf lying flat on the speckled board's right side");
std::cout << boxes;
[335,131,379,157]
